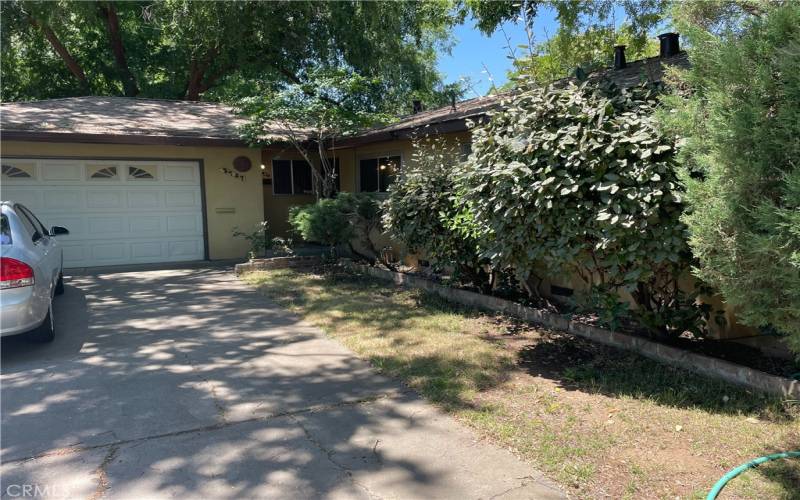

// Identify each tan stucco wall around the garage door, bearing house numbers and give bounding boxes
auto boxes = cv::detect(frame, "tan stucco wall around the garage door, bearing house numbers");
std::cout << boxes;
[0,141,264,259]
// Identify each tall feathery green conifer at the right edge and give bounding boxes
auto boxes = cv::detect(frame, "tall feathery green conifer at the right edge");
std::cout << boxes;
[660,2,800,352]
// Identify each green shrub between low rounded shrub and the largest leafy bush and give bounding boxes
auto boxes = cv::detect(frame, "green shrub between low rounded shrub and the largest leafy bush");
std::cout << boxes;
[383,137,489,286]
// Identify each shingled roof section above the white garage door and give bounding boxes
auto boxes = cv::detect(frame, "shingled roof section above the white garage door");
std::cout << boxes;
[0,96,262,146]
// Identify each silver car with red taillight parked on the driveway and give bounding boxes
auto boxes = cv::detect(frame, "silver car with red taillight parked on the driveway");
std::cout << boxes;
[0,201,69,342]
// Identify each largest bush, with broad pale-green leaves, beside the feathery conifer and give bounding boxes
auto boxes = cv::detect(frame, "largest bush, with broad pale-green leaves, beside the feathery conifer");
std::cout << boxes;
[459,82,695,333]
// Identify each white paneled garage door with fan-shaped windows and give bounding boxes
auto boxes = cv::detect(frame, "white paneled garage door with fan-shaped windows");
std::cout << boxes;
[0,157,204,267]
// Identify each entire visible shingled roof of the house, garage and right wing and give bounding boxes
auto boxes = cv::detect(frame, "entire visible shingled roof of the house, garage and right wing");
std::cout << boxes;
[0,52,689,149]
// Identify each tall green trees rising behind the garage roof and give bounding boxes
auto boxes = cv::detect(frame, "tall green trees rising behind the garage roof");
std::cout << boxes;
[0,0,456,105]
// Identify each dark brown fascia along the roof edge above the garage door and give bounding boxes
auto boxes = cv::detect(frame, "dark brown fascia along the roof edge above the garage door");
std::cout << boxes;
[0,130,250,148]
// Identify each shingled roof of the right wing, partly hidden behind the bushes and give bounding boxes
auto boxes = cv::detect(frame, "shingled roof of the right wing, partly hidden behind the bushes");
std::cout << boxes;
[337,52,689,148]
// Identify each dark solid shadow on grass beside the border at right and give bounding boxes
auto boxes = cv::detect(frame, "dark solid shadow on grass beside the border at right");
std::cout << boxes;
[519,332,800,422]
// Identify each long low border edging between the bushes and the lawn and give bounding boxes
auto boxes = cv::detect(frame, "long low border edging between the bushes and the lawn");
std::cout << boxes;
[345,263,800,398]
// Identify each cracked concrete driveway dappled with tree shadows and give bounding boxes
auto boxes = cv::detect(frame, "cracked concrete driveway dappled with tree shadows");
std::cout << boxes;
[0,268,563,500]
